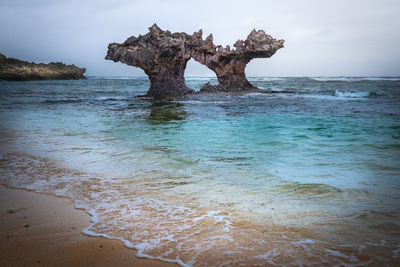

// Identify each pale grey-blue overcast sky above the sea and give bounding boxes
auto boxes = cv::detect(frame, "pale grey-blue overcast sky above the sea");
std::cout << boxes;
[0,0,400,77]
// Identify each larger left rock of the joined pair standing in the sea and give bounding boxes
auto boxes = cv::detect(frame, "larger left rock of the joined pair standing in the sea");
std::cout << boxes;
[106,24,206,99]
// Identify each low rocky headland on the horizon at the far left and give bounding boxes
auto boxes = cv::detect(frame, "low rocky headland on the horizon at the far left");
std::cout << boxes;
[0,54,86,81]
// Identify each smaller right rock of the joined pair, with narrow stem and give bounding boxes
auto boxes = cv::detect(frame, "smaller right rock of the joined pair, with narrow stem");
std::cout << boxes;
[192,30,284,92]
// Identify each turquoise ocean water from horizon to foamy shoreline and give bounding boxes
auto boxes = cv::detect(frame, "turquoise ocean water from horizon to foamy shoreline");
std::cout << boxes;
[0,77,400,266]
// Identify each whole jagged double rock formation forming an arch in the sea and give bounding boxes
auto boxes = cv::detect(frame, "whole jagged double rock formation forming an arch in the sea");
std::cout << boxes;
[106,24,284,99]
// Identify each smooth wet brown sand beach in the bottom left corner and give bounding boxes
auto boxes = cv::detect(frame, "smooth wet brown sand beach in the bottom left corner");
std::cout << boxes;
[0,186,179,267]
